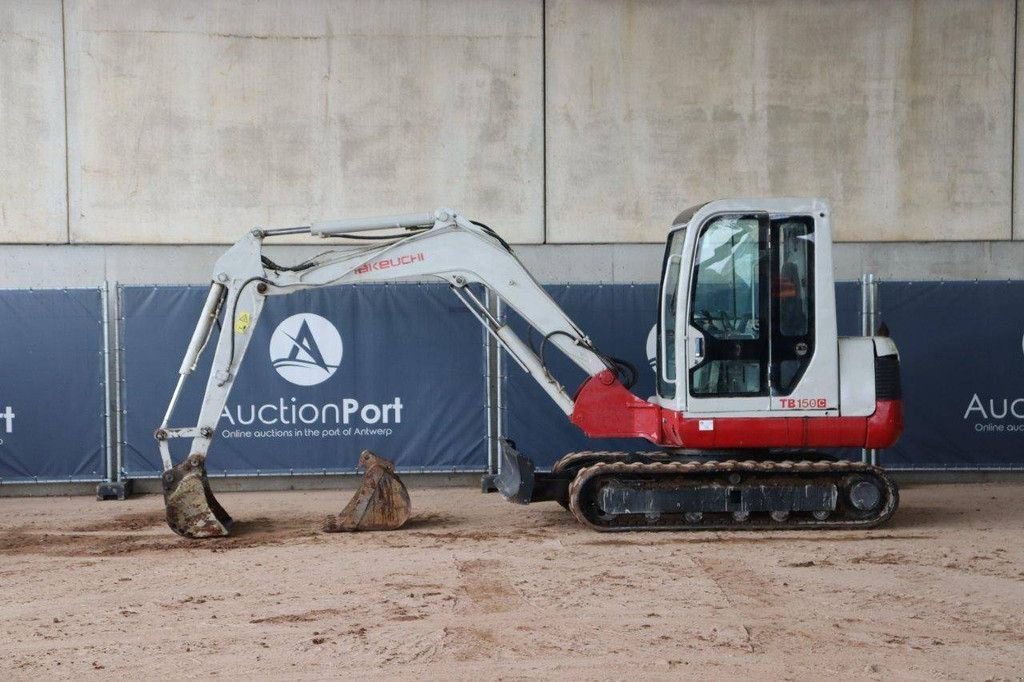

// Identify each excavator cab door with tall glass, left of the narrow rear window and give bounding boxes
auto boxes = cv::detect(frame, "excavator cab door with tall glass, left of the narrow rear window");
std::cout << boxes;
[685,213,771,416]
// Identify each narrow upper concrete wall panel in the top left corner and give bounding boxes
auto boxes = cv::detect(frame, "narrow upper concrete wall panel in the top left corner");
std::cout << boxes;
[0,0,68,243]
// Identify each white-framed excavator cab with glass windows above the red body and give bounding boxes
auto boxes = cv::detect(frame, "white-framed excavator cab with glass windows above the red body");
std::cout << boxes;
[657,200,839,417]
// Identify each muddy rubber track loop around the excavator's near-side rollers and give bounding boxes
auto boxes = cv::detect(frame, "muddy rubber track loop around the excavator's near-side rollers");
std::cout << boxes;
[563,453,899,531]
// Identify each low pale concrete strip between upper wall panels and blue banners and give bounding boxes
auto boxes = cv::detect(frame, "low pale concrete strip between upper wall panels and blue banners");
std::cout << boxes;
[6,241,1024,288]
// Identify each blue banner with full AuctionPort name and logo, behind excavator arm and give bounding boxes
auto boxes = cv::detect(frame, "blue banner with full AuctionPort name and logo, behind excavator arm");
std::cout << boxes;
[121,284,486,476]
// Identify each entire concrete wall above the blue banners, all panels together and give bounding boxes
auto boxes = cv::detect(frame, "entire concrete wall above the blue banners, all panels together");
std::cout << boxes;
[0,0,1024,278]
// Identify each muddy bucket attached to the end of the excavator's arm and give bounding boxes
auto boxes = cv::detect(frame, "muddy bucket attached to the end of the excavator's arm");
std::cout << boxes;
[162,455,231,538]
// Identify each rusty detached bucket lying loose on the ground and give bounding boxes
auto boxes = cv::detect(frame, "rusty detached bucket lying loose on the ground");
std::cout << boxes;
[324,450,412,532]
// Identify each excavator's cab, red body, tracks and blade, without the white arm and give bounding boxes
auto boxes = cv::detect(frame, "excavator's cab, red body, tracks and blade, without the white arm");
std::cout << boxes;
[499,199,902,530]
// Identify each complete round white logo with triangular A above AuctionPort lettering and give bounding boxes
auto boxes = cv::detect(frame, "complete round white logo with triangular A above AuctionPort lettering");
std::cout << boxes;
[270,312,342,386]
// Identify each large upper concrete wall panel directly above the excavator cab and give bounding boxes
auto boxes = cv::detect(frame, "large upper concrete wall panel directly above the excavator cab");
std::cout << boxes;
[546,0,1014,243]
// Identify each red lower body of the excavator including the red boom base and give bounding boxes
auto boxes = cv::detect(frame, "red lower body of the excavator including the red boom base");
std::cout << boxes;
[570,370,903,450]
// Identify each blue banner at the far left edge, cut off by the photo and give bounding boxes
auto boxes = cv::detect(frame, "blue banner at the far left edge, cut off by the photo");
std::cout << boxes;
[0,289,106,482]
